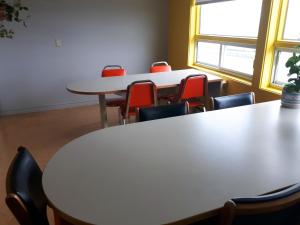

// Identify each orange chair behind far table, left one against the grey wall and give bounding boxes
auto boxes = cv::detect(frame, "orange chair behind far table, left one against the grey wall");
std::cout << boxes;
[101,65,126,107]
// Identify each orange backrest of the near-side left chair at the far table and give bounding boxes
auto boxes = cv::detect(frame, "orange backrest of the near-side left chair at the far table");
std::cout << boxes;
[126,80,157,113]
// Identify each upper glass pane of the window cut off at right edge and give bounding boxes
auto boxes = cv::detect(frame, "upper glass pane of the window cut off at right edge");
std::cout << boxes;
[283,0,300,41]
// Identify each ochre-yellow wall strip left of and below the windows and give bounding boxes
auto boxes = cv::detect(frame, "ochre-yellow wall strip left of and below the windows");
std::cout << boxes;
[168,0,280,102]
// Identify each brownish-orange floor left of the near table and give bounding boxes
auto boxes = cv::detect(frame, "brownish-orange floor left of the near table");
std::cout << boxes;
[0,106,118,225]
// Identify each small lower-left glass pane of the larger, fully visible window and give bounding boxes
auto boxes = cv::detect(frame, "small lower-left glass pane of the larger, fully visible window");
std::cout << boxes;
[196,42,220,66]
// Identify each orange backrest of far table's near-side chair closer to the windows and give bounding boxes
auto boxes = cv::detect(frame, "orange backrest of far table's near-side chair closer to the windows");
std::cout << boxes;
[179,75,208,100]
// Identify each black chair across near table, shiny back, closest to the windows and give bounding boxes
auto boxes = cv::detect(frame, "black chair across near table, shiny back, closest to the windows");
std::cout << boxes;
[211,92,255,110]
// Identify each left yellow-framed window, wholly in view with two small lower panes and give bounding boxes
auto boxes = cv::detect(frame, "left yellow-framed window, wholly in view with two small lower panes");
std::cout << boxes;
[192,0,262,79]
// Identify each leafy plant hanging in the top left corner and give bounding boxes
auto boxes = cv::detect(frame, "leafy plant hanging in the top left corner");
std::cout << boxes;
[0,0,28,39]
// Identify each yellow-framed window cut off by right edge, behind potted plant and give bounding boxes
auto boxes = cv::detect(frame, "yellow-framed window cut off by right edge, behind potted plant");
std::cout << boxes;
[270,0,300,86]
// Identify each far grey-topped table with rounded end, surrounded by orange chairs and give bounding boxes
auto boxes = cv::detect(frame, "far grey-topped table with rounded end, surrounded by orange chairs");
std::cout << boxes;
[66,69,222,127]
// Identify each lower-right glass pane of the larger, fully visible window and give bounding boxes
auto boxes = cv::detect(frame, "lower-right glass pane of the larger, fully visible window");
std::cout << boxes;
[221,45,255,75]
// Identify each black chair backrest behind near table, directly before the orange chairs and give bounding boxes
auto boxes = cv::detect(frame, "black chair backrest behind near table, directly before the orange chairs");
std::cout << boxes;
[138,102,189,122]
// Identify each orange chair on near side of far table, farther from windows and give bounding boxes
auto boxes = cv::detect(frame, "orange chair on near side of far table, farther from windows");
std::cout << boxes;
[120,80,157,124]
